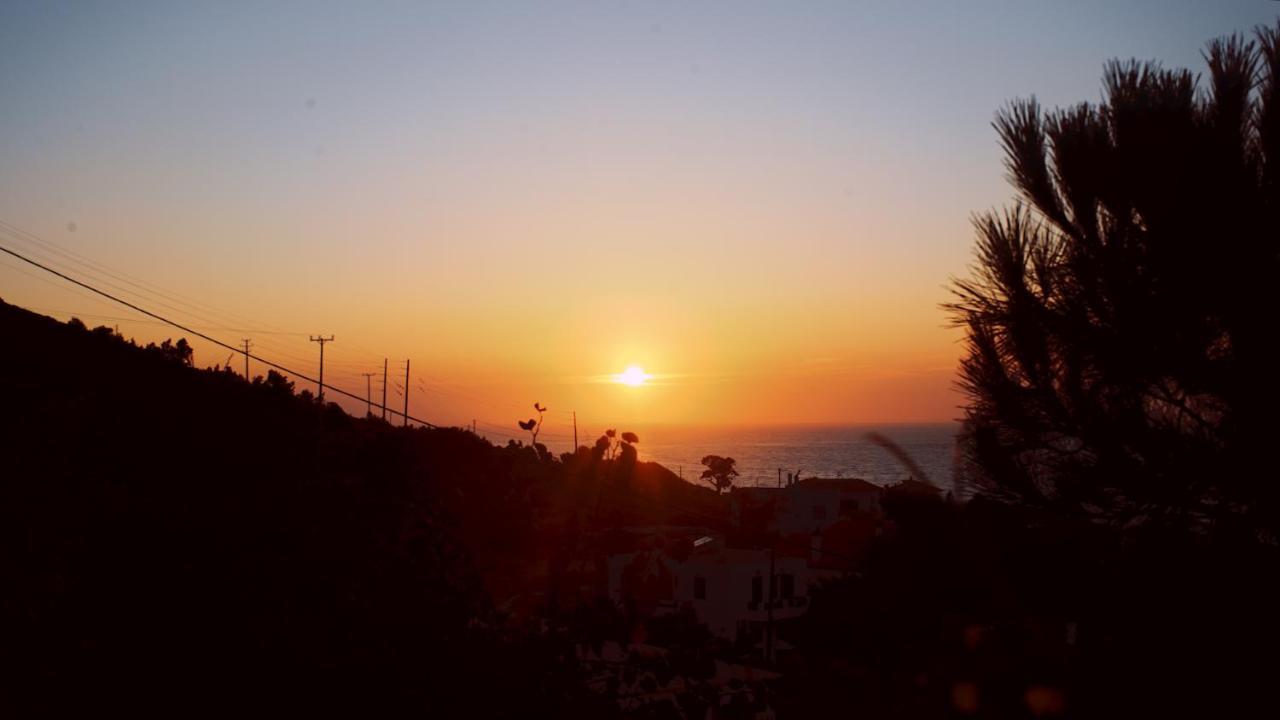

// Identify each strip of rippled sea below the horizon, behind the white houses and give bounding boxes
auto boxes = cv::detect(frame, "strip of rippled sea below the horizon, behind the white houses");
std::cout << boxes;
[640,423,959,488]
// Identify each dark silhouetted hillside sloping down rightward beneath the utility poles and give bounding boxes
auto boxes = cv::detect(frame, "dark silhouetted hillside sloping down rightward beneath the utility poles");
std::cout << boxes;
[0,297,722,715]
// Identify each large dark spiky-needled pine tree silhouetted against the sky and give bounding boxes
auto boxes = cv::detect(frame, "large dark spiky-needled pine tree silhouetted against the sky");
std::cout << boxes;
[947,28,1280,530]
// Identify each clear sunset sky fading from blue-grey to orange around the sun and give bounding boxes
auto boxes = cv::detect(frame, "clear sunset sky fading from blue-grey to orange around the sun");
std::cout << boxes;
[0,0,1280,439]
